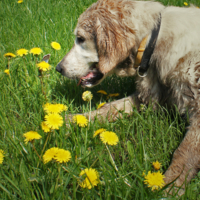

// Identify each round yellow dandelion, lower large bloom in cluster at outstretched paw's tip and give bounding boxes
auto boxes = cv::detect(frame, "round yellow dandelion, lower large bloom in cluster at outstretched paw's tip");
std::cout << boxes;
[44,113,63,129]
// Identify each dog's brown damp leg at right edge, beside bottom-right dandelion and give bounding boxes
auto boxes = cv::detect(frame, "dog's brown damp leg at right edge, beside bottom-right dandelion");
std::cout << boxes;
[165,115,200,195]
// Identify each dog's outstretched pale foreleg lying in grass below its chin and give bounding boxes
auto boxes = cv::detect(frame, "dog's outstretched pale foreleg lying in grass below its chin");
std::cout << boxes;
[66,93,140,121]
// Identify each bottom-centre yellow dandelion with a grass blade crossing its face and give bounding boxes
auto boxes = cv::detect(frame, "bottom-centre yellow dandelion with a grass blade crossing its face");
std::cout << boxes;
[79,168,99,189]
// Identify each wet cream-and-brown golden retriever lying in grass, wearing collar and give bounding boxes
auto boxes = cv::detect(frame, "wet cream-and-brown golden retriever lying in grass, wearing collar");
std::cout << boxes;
[56,0,200,195]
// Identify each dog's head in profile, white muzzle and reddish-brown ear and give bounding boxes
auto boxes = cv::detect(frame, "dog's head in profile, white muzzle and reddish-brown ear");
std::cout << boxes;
[56,0,137,87]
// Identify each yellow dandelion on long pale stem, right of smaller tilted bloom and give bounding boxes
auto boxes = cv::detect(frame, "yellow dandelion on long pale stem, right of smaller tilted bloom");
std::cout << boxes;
[100,131,119,145]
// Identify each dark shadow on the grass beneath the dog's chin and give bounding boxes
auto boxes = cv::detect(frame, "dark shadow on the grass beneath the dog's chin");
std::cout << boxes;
[52,76,135,107]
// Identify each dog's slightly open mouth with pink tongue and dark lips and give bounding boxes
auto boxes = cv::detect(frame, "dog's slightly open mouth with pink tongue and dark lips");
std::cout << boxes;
[78,63,104,87]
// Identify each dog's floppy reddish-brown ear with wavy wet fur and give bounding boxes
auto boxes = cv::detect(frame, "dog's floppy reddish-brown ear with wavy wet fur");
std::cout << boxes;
[96,15,134,74]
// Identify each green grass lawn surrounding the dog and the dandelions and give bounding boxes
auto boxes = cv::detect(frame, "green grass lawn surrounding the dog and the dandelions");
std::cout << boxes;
[0,0,200,200]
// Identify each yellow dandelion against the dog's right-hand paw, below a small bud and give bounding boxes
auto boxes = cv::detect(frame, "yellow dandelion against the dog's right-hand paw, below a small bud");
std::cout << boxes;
[144,171,165,191]
